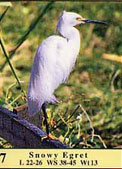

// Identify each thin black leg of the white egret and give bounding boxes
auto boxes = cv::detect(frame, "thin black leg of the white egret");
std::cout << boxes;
[42,104,49,135]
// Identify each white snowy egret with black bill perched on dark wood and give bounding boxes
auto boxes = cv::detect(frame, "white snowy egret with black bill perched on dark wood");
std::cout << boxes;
[27,11,106,135]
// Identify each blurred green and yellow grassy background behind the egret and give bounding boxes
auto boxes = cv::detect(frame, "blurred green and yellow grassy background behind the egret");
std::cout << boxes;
[0,2,122,148]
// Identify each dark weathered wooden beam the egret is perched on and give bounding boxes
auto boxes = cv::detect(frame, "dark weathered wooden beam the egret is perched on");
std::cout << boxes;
[0,106,69,148]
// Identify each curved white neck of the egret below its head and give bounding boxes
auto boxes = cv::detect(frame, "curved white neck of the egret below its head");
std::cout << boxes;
[58,25,80,55]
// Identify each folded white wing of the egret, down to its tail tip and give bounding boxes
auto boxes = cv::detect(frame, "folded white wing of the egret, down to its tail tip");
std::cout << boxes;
[27,36,68,116]
